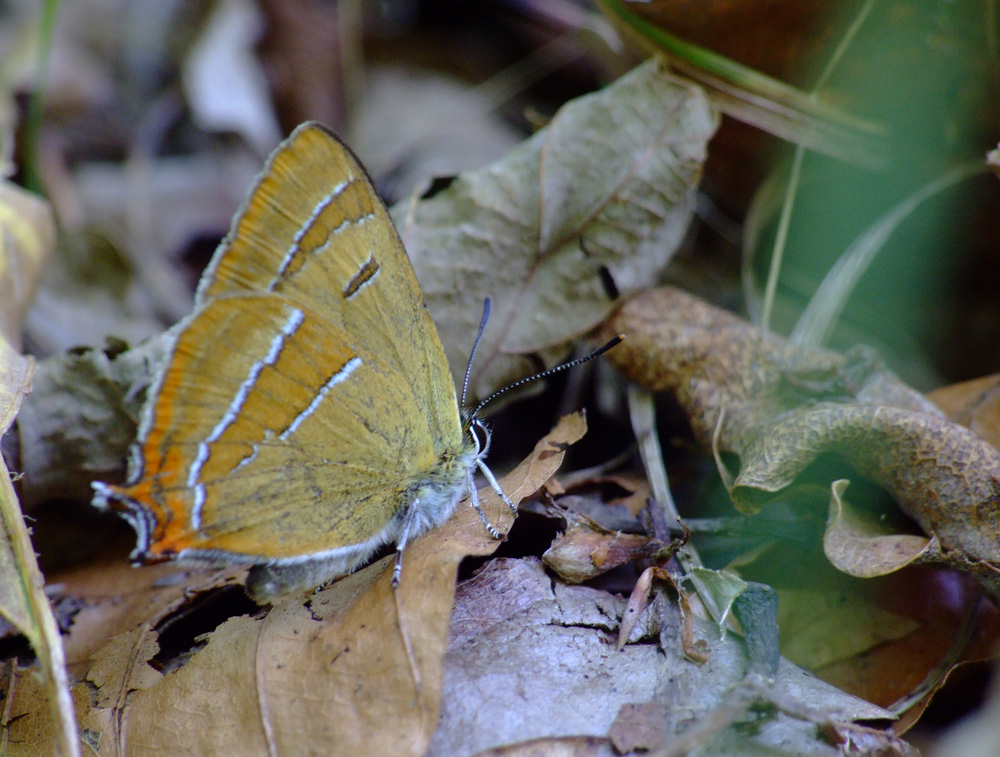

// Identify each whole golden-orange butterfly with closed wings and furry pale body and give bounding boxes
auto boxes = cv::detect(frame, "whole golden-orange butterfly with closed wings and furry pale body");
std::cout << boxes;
[94,124,488,599]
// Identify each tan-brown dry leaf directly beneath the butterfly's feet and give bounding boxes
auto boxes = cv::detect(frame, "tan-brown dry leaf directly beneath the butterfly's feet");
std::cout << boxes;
[27,415,586,755]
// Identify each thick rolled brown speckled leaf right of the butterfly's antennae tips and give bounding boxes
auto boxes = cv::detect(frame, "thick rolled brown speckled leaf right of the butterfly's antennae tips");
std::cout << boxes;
[604,287,1000,593]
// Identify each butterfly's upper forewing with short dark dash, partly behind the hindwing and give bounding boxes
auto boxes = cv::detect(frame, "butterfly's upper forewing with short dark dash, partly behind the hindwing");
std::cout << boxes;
[198,123,462,445]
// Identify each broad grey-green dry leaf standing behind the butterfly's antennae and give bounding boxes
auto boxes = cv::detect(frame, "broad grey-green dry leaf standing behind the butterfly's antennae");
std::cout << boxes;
[393,61,717,396]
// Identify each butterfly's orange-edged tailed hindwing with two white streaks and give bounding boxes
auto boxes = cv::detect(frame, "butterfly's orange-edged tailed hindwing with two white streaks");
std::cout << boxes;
[115,294,437,559]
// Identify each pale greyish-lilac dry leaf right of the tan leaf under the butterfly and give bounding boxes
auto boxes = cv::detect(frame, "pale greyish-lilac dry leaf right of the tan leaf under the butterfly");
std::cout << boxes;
[428,558,887,757]
